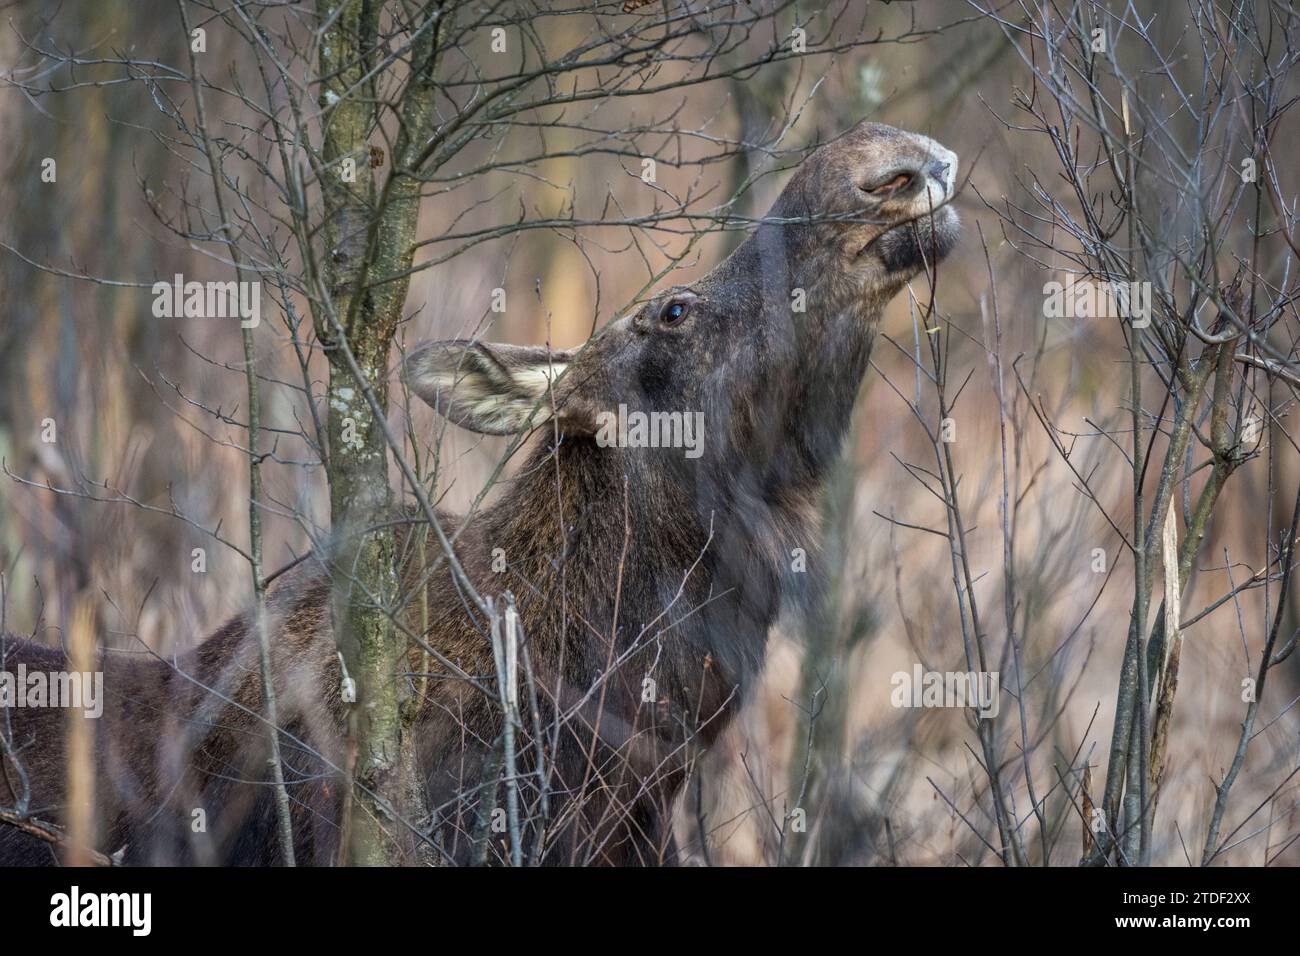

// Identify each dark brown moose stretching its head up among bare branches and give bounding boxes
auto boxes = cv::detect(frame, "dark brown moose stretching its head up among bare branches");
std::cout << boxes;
[0,122,958,865]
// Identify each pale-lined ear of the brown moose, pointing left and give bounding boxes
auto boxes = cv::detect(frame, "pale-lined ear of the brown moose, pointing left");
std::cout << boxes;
[402,339,585,434]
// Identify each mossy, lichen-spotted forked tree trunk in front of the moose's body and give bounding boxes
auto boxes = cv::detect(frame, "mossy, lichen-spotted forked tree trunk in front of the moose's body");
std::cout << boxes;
[317,0,439,865]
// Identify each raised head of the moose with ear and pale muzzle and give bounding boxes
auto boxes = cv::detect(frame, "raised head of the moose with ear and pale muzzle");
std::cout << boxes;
[406,122,958,530]
